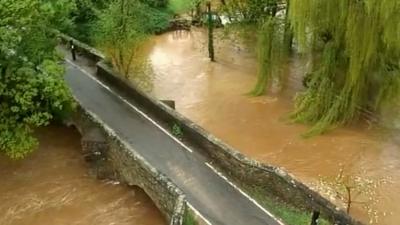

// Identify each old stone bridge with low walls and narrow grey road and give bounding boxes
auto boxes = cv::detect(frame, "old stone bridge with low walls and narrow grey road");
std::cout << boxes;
[60,36,361,225]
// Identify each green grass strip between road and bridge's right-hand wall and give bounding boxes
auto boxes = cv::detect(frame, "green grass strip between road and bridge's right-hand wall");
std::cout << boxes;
[245,187,331,225]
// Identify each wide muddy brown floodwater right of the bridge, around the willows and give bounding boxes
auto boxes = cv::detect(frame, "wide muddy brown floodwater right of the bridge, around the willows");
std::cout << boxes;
[138,29,400,225]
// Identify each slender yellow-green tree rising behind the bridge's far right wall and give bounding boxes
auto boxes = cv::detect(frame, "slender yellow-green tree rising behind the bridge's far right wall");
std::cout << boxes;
[93,0,169,78]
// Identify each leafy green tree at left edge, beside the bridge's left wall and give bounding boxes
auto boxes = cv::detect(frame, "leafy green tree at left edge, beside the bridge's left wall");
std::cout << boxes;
[0,0,73,159]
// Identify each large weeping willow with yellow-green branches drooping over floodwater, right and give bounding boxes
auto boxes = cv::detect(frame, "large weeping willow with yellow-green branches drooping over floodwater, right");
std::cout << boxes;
[289,0,400,135]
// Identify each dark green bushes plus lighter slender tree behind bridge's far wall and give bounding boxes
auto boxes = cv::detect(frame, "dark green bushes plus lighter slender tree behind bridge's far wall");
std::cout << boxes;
[64,0,174,77]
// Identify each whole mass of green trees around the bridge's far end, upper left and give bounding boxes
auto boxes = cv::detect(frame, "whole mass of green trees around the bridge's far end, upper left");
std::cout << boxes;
[0,0,178,159]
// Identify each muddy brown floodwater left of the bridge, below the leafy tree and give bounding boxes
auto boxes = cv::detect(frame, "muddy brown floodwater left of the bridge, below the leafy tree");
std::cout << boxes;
[0,127,166,225]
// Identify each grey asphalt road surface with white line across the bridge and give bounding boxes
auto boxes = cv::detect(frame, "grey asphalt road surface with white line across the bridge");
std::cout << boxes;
[65,60,283,225]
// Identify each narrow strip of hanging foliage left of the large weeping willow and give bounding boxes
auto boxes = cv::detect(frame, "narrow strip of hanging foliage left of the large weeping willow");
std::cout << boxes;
[222,0,292,96]
